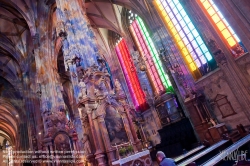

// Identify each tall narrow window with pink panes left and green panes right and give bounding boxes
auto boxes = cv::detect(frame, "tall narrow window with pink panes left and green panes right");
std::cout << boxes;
[129,16,173,94]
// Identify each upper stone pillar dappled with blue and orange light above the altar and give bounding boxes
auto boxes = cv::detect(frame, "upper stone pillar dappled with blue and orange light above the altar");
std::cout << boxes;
[56,0,97,68]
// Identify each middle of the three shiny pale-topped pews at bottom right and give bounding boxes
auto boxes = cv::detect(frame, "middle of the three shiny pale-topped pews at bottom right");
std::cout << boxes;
[178,140,232,166]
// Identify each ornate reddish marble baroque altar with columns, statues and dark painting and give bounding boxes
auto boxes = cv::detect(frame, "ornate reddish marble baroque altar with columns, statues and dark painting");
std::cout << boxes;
[78,65,142,166]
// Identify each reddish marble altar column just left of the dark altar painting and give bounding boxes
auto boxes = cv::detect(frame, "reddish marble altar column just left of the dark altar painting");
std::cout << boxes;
[98,116,116,165]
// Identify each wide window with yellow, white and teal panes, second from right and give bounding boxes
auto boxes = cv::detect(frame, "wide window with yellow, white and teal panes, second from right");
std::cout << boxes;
[153,0,216,80]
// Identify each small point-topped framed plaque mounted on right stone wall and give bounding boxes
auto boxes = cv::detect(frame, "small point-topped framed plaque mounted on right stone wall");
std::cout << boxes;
[214,94,236,118]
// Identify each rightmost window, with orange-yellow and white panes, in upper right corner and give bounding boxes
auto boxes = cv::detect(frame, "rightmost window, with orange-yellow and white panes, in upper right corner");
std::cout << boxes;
[198,0,247,58]
